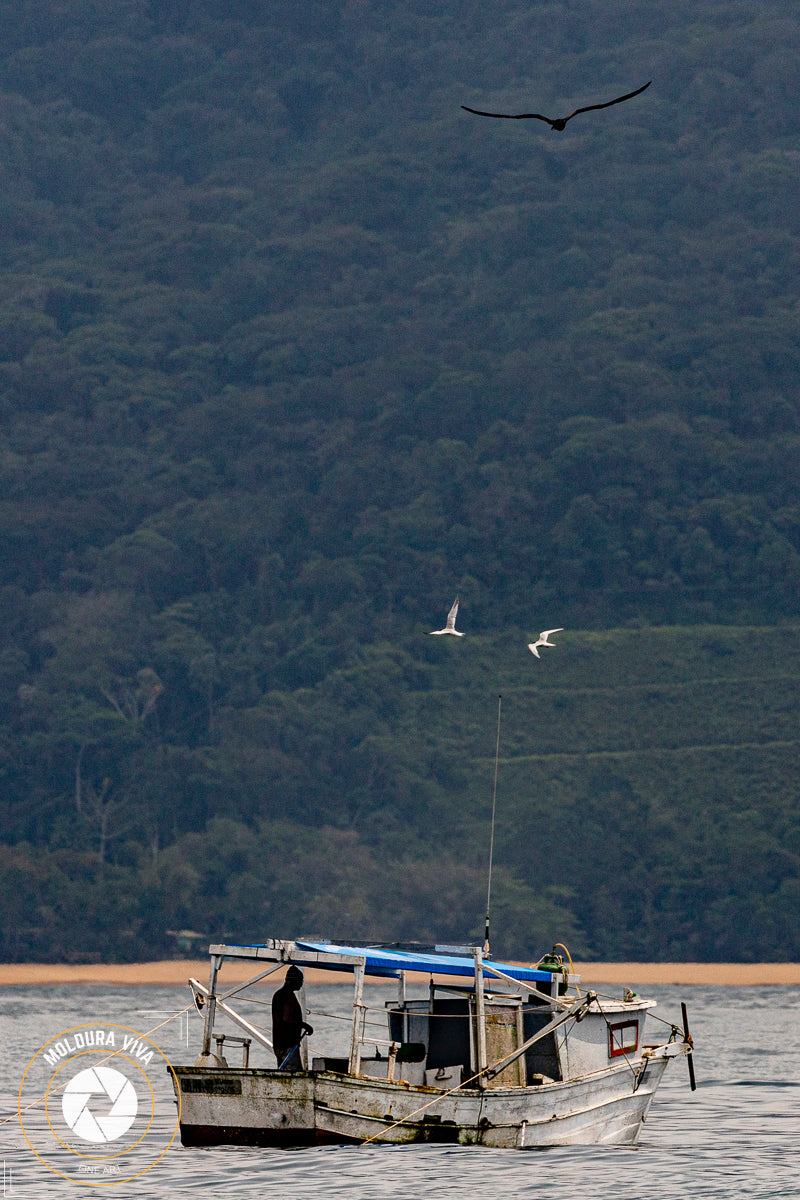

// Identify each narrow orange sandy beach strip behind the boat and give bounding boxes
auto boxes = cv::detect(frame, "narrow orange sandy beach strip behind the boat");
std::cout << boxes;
[0,959,800,988]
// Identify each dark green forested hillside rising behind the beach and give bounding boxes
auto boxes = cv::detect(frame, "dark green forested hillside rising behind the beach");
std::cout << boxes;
[0,0,800,959]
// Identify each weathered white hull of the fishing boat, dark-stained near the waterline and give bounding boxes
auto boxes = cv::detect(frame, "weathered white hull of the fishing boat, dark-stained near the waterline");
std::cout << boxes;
[175,1043,685,1147]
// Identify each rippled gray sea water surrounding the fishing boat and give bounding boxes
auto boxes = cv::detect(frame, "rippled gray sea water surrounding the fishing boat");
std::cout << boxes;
[0,979,800,1200]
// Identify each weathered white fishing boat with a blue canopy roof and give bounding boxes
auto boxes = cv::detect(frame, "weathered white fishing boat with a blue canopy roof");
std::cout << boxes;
[172,938,694,1147]
